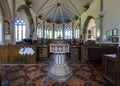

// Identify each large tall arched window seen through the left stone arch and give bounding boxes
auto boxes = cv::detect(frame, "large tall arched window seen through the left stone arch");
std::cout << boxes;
[15,19,26,41]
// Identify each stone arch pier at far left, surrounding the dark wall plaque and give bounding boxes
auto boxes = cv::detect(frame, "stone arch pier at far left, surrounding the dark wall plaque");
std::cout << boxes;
[0,0,13,45]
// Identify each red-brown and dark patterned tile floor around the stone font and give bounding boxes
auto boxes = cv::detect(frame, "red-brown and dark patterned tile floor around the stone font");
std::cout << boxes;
[1,62,112,86]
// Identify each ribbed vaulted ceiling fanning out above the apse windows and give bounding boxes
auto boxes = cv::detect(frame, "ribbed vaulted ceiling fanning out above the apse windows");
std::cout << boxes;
[26,0,93,24]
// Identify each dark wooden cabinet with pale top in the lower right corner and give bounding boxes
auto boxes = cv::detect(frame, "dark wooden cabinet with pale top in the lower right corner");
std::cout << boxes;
[103,54,120,86]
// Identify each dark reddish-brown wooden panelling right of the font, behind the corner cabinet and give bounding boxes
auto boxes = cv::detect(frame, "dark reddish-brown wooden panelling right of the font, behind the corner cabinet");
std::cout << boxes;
[81,45,117,63]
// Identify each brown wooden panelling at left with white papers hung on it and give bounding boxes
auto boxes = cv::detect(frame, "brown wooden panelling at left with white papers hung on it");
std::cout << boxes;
[0,45,36,64]
